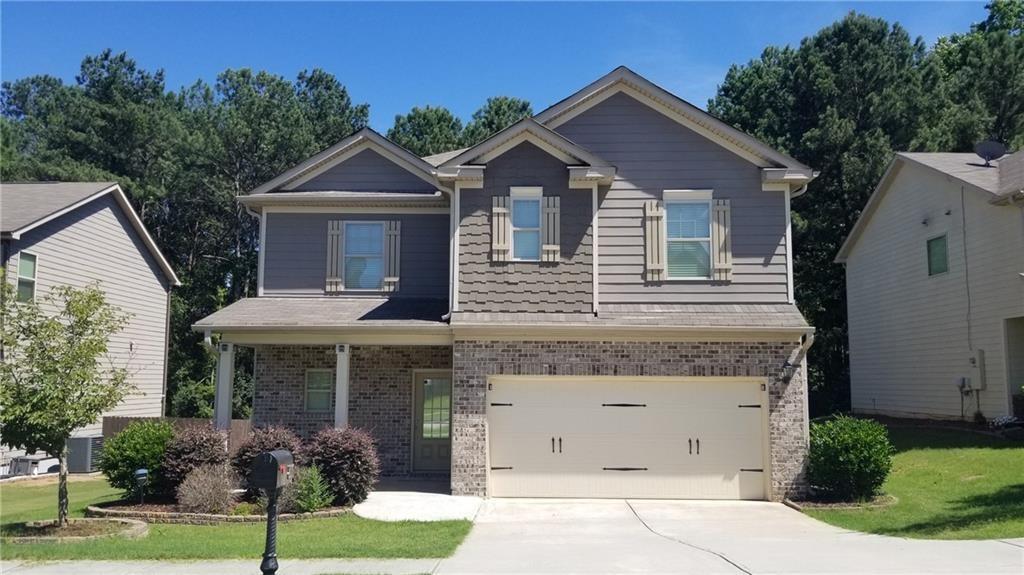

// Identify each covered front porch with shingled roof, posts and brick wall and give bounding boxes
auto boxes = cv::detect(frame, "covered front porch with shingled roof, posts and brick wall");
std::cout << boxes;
[197,298,452,478]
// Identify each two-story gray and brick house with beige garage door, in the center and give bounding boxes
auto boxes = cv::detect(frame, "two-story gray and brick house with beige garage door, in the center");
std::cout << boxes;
[196,68,814,499]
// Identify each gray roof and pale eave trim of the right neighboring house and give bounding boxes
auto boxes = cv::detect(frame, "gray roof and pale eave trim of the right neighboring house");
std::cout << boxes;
[836,151,1024,263]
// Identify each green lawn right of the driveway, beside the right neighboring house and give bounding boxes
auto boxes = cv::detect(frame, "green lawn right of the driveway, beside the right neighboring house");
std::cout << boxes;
[807,427,1024,539]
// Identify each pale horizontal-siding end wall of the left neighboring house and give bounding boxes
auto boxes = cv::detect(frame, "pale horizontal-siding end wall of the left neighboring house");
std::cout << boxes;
[7,195,167,435]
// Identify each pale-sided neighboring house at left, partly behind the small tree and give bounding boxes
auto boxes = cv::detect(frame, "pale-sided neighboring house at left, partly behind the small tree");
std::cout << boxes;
[0,182,178,467]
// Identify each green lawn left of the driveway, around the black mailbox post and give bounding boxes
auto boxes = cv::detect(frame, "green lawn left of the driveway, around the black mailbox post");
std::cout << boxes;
[0,472,472,560]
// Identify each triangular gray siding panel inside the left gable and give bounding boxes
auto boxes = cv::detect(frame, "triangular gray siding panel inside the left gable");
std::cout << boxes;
[288,149,436,191]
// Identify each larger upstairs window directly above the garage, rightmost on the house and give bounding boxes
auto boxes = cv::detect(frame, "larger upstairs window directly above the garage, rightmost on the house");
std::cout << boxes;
[665,190,711,279]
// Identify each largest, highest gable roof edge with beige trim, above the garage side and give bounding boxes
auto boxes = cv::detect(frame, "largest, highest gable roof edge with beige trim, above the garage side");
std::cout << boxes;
[534,65,813,173]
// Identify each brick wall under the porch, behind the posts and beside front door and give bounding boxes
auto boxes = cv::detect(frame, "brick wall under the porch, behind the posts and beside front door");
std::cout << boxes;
[253,345,452,476]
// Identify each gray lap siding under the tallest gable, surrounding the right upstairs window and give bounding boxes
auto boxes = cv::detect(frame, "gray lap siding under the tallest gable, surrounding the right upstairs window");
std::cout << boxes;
[557,94,786,304]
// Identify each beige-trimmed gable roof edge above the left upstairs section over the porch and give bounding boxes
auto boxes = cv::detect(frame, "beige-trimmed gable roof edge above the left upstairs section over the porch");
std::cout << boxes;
[249,128,444,195]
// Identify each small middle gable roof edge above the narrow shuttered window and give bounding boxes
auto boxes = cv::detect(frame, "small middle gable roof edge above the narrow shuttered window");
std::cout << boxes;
[439,118,611,168]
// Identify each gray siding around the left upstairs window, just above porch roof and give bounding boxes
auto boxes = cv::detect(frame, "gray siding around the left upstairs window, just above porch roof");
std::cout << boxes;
[263,209,449,299]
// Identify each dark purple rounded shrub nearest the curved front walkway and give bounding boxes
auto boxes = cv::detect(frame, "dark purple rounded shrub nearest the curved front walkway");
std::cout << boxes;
[306,428,380,505]
